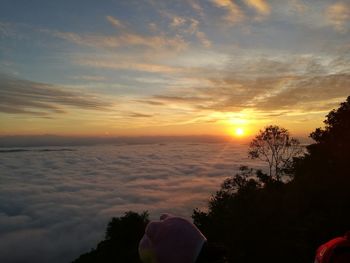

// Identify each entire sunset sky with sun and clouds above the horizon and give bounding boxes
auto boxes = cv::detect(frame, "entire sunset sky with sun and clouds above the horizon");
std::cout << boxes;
[0,0,350,139]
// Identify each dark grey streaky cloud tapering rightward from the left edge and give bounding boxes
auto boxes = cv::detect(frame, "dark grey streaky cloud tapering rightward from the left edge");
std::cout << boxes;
[0,75,112,116]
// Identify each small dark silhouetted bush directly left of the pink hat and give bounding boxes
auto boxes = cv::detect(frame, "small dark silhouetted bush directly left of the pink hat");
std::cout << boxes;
[73,211,149,263]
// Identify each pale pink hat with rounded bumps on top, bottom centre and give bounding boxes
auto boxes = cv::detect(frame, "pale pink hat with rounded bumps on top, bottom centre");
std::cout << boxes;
[139,214,206,263]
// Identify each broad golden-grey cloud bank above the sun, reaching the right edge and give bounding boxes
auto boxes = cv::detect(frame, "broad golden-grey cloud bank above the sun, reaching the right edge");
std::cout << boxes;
[134,56,350,114]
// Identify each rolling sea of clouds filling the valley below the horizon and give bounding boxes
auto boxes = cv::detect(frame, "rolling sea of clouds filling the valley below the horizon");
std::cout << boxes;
[0,143,263,263]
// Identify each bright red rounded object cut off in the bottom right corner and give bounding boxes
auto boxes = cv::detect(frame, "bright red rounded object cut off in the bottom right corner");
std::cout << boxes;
[315,232,350,263]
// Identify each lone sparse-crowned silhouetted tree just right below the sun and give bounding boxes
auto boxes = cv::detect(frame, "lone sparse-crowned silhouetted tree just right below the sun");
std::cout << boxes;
[248,125,302,181]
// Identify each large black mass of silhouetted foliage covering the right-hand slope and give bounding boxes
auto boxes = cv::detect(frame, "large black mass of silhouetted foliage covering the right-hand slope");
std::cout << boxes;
[193,97,350,263]
